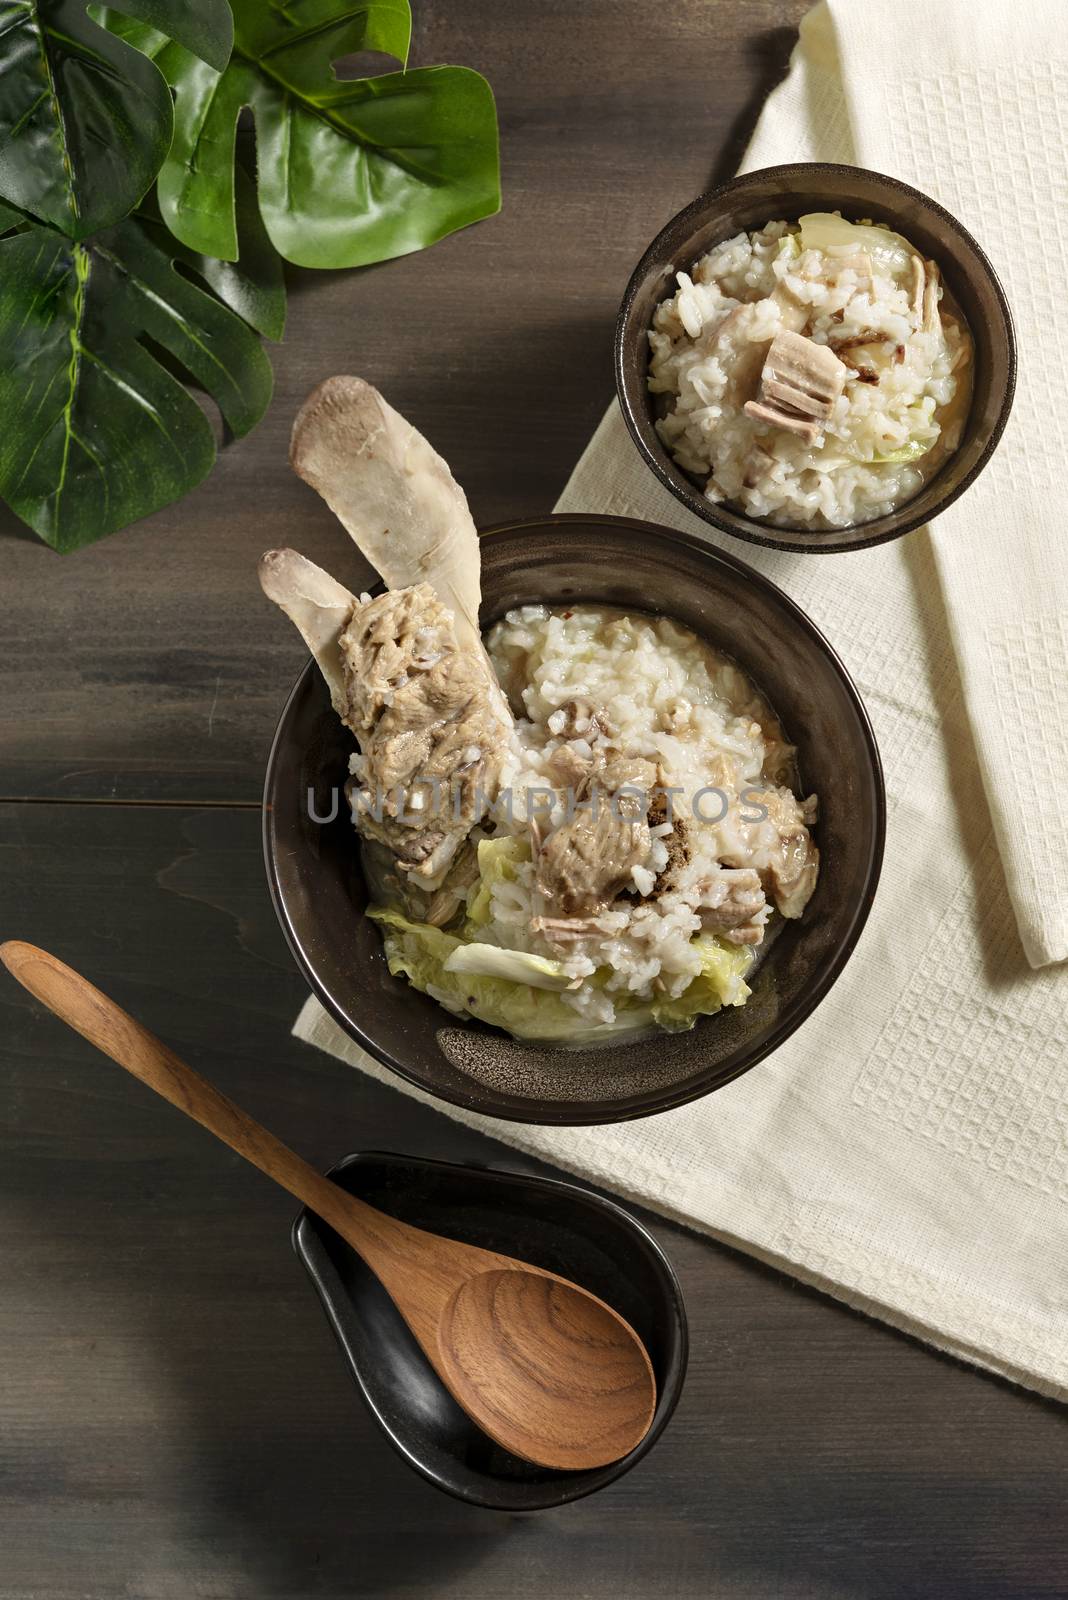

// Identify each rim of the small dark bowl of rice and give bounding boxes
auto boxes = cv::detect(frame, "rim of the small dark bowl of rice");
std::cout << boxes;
[612,162,1018,555]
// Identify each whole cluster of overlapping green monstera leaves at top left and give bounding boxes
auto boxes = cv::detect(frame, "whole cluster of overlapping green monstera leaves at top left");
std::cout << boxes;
[0,0,500,550]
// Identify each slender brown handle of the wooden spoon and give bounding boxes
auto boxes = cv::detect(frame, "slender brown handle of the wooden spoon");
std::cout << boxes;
[0,939,370,1248]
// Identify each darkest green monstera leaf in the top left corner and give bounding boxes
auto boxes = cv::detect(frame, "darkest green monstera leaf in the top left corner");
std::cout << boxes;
[0,0,233,238]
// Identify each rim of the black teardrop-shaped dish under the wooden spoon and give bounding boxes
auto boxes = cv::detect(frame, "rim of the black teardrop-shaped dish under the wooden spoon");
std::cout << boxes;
[289,1149,689,1515]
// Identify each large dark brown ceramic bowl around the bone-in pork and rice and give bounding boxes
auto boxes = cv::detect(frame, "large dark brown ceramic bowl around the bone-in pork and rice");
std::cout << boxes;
[264,517,886,1123]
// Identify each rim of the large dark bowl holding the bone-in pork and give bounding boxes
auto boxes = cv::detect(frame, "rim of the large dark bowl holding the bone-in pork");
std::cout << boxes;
[261,512,887,1128]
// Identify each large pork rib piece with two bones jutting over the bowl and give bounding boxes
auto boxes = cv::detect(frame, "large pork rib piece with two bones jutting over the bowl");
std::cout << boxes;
[261,376,512,910]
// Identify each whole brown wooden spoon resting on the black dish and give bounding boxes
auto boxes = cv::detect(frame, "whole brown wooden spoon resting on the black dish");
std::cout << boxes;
[0,941,656,1470]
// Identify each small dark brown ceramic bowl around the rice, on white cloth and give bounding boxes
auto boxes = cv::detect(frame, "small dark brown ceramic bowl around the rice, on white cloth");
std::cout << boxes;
[616,162,1017,554]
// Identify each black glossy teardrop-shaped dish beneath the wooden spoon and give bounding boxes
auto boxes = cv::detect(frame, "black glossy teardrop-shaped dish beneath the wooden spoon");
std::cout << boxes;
[293,1150,687,1512]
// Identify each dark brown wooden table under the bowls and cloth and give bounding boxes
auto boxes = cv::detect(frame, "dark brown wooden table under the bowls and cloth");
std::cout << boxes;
[0,0,1068,1600]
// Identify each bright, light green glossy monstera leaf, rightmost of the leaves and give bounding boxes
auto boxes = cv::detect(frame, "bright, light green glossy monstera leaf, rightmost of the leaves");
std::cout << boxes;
[126,0,500,267]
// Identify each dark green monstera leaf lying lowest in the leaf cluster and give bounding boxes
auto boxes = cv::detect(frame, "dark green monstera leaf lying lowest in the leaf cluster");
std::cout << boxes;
[0,218,278,550]
